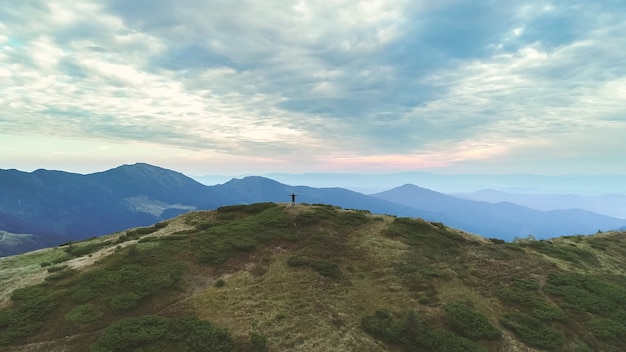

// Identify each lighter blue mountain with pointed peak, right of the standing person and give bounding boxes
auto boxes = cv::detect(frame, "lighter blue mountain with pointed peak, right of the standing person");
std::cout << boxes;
[372,184,626,241]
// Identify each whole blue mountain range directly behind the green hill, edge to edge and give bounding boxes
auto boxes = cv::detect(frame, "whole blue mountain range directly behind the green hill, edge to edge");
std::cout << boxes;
[0,163,626,256]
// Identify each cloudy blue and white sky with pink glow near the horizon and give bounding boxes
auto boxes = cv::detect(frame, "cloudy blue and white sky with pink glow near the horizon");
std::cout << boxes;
[0,0,626,175]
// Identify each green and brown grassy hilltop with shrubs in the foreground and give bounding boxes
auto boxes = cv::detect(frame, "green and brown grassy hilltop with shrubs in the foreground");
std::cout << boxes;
[0,203,626,352]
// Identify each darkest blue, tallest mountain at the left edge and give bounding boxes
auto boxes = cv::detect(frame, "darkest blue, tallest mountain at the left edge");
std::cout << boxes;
[0,164,226,254]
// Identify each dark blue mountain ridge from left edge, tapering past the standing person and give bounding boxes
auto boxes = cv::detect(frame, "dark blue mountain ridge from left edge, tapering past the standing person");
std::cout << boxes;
[0,163,434,256]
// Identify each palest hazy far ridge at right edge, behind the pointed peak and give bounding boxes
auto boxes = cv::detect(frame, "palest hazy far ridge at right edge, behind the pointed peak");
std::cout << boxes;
[452,189,626,219]
